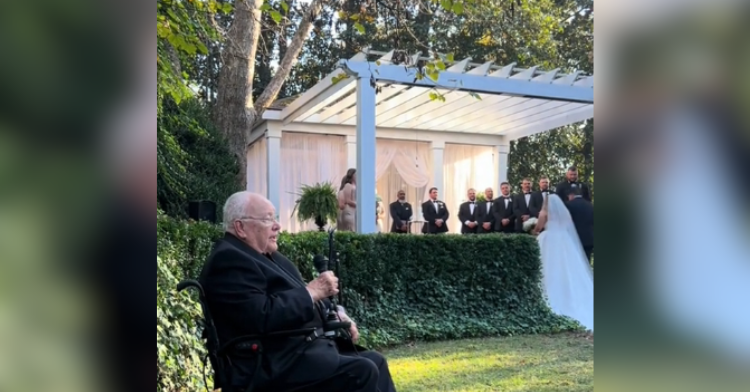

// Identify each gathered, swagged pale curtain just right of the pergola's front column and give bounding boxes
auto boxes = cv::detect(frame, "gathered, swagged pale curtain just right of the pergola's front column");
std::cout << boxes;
[373,139,432,232]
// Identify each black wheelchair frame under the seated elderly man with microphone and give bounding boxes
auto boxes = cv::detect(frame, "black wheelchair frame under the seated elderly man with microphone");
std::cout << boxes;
[177,279,316,392]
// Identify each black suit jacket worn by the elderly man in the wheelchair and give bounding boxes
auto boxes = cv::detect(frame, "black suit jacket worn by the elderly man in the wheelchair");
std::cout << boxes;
[200,234,339,389]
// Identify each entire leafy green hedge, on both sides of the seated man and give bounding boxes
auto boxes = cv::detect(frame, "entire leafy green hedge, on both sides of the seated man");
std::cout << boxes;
[157,215,577,390]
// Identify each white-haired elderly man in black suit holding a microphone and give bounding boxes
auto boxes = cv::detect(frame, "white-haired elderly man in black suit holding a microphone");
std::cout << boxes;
[200,192,395,392]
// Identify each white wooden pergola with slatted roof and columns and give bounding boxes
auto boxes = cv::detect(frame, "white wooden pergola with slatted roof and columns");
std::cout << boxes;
[250,51,594,233]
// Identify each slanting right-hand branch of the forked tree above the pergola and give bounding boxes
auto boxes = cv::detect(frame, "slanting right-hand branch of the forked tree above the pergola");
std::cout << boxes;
[253,0,326,118]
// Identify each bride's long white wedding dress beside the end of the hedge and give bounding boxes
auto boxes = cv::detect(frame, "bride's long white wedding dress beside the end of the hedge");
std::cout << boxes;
[537,194,594,332]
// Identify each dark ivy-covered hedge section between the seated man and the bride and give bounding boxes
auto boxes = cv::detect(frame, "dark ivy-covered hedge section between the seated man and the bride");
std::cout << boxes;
[279,232,575,347]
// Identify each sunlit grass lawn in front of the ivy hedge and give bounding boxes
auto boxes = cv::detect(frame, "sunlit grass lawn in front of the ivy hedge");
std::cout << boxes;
[385,334,594,392]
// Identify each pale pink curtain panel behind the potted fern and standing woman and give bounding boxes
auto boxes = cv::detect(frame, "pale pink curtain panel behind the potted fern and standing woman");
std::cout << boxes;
[279,132,348,233]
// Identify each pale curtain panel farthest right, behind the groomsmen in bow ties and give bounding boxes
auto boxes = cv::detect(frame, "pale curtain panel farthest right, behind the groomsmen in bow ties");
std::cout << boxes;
[440,144,499,233]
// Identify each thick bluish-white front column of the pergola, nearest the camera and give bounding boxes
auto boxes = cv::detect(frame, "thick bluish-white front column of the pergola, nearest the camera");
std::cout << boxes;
[347,77,377,234]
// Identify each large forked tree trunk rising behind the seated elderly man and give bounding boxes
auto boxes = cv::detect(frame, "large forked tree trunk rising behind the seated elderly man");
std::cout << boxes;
[214,0,324,189]
